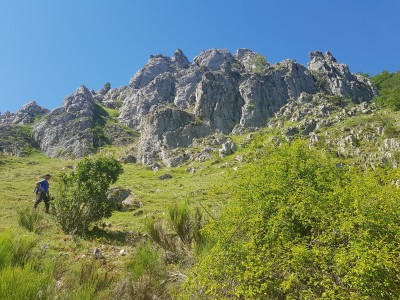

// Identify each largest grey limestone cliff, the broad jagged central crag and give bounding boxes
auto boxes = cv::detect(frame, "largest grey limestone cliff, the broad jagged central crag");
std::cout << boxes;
[115,49,376,163]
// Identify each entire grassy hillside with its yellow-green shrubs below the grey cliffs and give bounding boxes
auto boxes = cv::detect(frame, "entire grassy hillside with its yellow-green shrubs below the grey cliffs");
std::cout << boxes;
[0,73,400,299]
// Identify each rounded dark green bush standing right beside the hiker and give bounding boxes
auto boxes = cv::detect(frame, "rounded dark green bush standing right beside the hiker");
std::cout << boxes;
[53,156,123,234]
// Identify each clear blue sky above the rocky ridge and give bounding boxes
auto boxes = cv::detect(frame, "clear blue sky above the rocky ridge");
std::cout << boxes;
[0,0,400,113]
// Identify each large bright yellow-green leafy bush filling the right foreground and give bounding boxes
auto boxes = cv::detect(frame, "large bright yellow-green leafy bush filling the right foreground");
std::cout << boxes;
[182,142,400,299]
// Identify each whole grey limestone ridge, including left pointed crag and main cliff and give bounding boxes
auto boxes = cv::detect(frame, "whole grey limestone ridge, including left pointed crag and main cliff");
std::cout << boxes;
[0,49,376,165]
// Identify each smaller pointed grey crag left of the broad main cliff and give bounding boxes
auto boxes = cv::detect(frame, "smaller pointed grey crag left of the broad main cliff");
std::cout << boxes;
[33,86,95,157]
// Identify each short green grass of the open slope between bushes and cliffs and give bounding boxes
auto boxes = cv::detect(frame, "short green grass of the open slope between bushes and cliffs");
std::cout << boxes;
[0,105,400,299]
